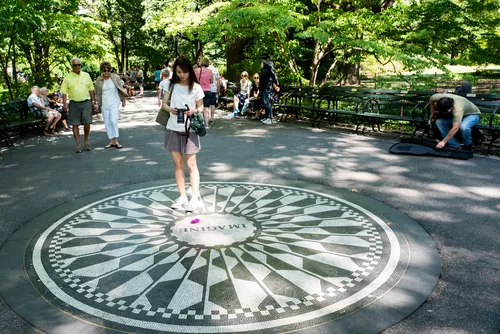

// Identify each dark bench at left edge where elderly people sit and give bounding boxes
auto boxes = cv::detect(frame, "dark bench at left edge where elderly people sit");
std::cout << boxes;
[0,100,44,146]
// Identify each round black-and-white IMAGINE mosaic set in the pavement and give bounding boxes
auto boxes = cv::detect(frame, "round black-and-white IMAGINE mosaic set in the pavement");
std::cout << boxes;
[26,182,409,333]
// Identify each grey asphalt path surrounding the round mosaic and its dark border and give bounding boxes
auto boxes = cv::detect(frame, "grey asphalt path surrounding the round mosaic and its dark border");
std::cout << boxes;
[0,92,500,333]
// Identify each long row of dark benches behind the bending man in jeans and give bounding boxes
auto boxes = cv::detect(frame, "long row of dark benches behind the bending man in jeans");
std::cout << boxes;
[274,87,500,153]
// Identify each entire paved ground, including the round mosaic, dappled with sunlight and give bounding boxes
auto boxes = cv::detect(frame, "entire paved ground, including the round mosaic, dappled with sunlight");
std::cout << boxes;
[0,90,500,333]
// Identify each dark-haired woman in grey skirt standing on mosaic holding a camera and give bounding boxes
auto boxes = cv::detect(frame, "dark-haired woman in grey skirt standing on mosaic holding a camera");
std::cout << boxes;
[162,56,205,212]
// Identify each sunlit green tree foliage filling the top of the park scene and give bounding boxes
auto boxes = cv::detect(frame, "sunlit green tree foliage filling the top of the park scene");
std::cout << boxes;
[0,0,500,98]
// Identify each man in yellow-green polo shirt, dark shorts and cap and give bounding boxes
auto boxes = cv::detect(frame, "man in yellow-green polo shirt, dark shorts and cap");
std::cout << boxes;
[61,58,97,153]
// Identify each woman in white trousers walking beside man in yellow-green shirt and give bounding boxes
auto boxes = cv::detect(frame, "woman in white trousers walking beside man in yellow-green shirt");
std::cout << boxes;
[95,61,128,148]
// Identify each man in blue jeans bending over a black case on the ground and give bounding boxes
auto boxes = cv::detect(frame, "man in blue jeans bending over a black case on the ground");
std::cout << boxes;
[430,94,481,150]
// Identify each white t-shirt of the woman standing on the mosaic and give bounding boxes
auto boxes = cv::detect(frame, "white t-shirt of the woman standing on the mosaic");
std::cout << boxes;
[165,81,205,132]
